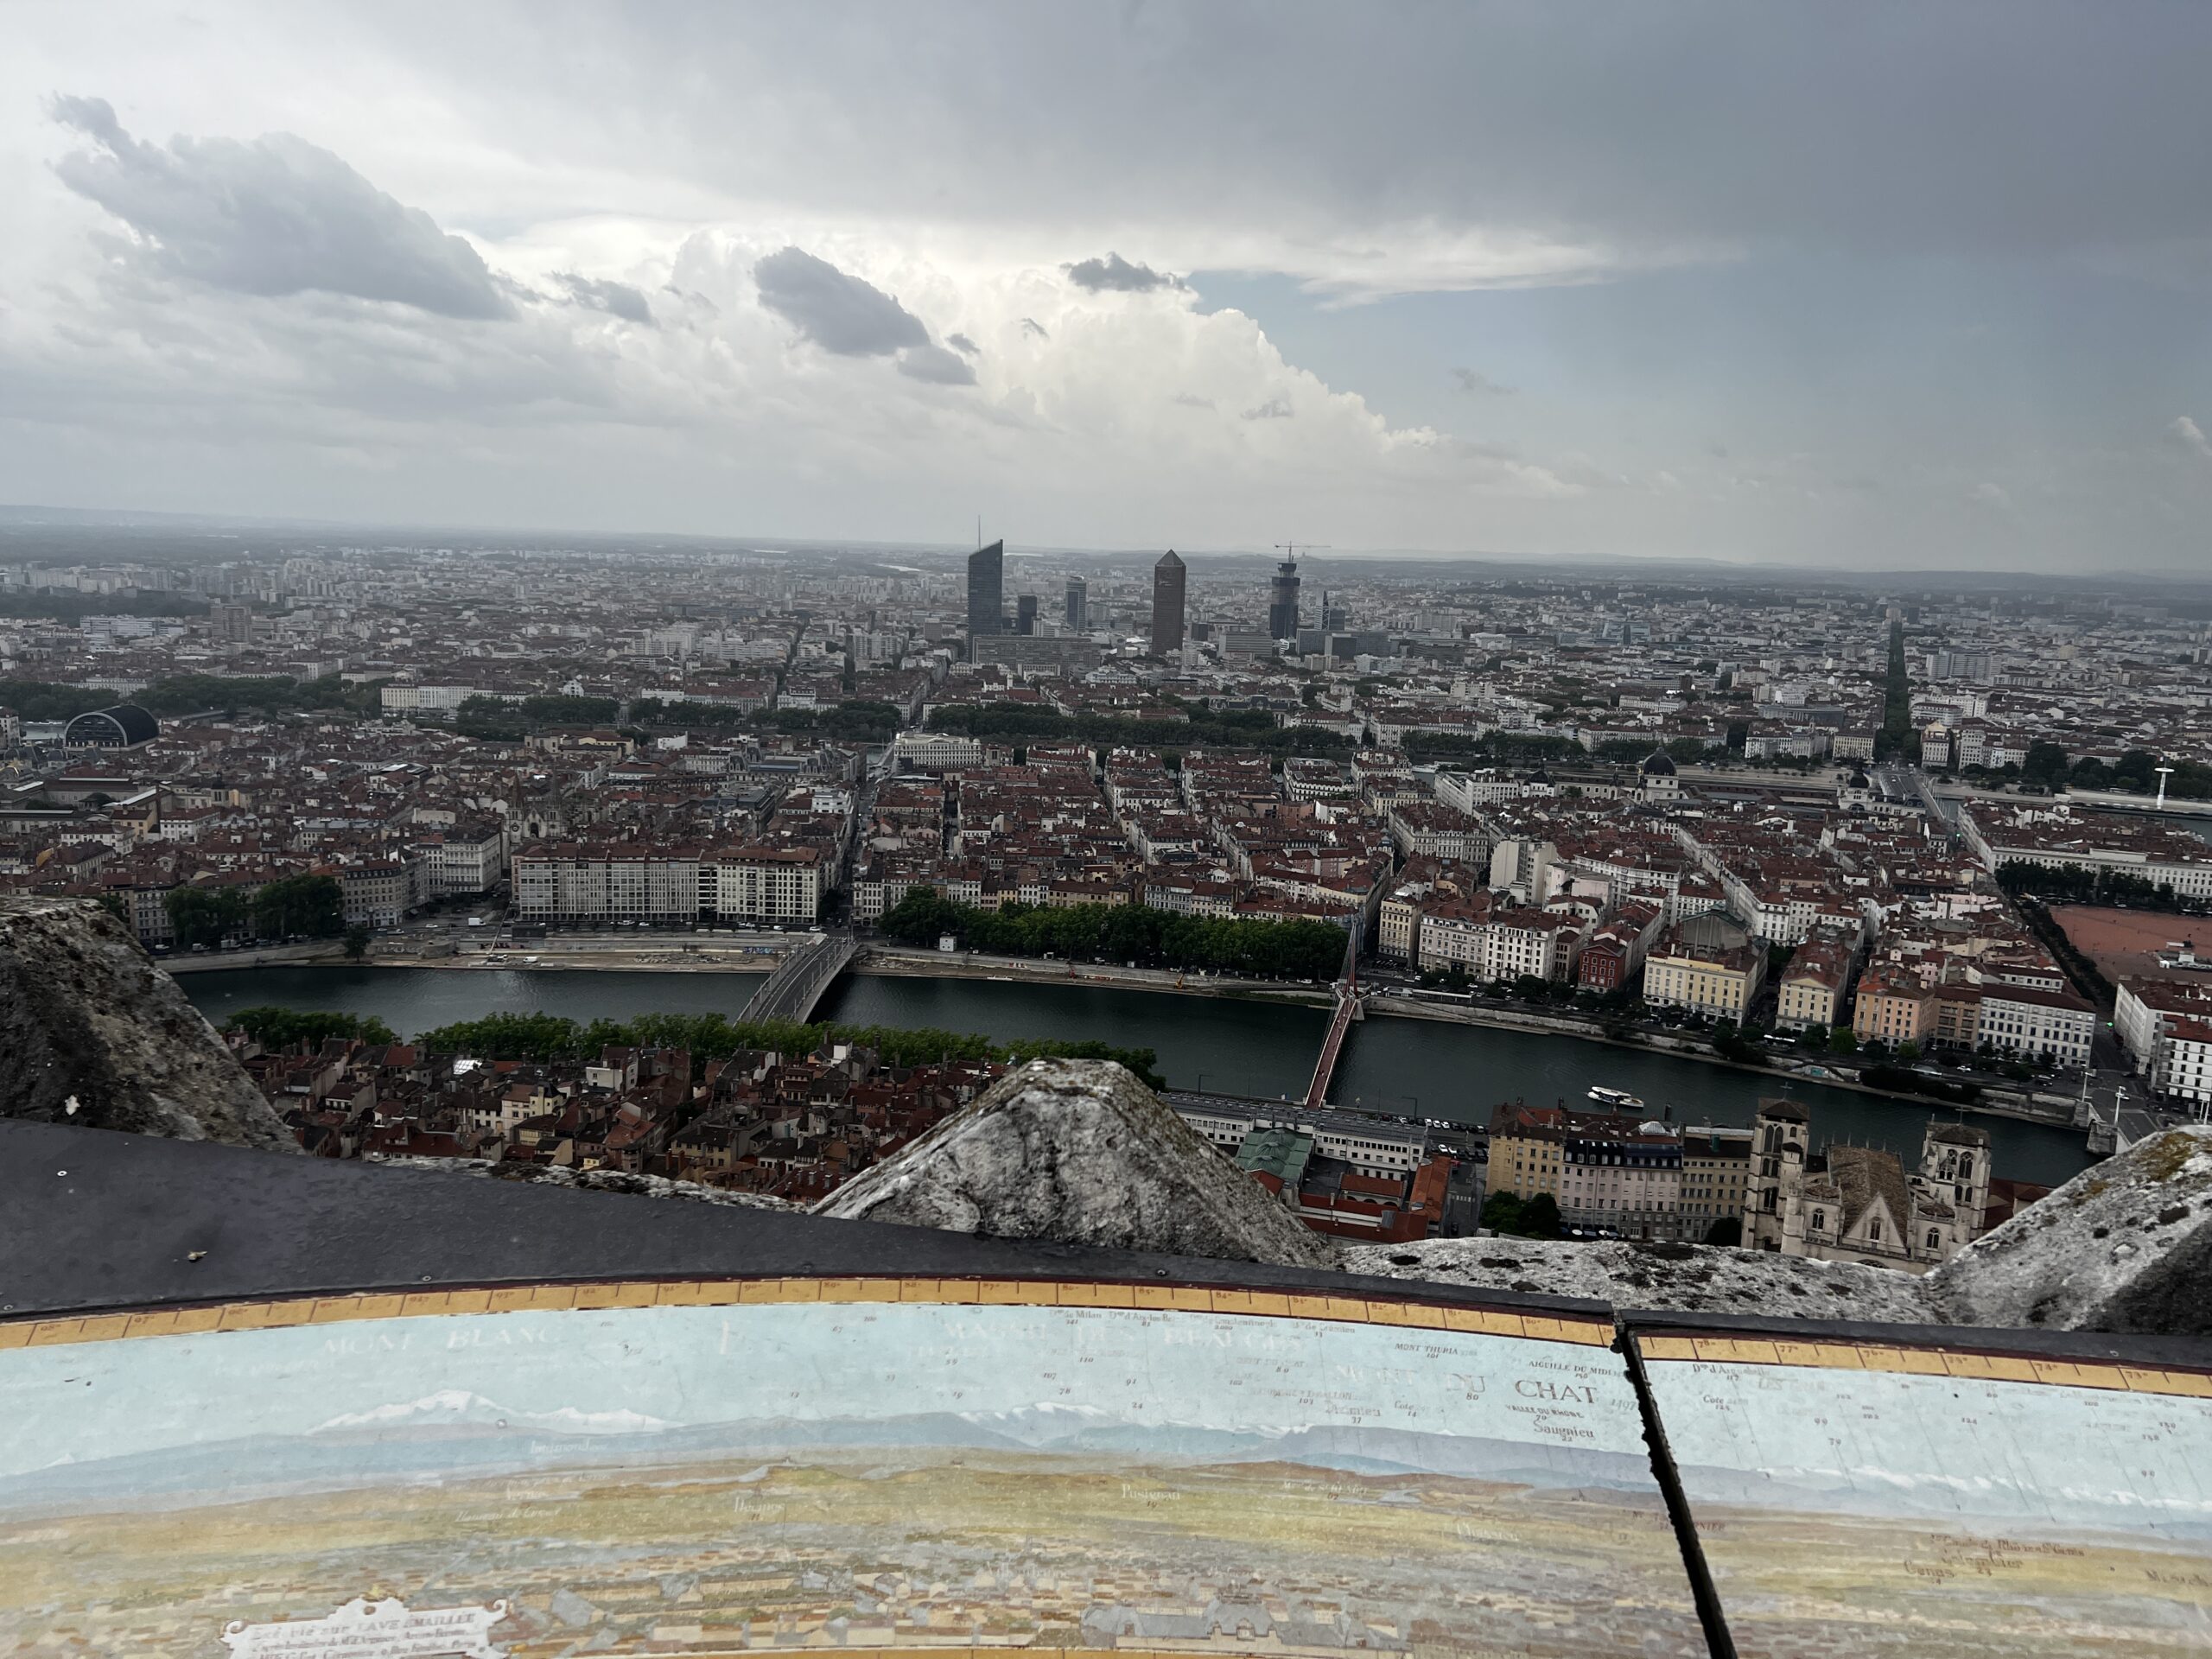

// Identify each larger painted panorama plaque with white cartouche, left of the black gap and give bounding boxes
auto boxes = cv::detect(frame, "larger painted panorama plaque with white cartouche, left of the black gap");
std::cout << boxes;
[0,1279,1703,1659]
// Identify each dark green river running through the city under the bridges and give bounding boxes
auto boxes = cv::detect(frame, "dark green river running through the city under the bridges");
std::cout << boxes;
[179,967,2090,1185]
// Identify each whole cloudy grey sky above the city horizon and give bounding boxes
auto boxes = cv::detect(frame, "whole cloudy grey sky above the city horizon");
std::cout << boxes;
[0,0,2212,570]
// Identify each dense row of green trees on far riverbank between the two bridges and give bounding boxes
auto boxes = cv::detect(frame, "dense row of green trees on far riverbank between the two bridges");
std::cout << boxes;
[882,887,1344,980]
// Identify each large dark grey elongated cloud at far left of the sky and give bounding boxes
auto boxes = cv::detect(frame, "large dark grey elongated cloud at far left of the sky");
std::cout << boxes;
[53,98,513,319]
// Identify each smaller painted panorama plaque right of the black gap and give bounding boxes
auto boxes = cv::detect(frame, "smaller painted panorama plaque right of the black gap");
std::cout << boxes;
[1637,1332,2212,1659]
